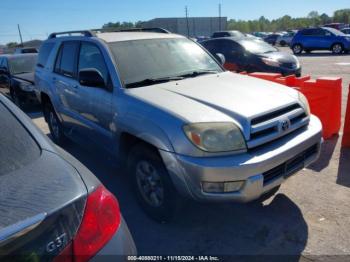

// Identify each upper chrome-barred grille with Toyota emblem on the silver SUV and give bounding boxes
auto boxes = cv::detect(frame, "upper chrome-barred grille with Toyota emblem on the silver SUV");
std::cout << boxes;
[247,104,309,149]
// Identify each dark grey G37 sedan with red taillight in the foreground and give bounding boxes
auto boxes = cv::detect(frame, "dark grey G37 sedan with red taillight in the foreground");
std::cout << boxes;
[0,95,136,261]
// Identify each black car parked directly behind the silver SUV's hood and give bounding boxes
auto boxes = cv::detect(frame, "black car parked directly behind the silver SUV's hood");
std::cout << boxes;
[200,37,301,76]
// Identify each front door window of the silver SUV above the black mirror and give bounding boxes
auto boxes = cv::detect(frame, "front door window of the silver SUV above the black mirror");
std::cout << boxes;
[78,42,109,84]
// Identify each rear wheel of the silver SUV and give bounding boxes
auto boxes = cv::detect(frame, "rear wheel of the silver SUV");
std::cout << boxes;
[44,103,67,145]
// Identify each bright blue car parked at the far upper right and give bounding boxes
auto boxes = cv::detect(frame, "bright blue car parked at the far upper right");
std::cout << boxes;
[291,27,350,54]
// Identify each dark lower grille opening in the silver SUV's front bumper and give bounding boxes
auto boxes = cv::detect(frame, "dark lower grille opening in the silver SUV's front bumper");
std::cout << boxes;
[263,144,318,186]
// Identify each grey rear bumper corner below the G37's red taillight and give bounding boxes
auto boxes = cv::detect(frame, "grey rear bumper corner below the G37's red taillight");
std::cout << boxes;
[90,217,137,262]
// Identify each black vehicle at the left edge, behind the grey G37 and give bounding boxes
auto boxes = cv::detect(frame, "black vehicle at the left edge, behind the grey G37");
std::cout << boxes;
[0,54,38,107]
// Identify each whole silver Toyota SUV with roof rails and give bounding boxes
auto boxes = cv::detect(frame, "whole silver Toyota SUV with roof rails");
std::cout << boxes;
[35,31,322,221]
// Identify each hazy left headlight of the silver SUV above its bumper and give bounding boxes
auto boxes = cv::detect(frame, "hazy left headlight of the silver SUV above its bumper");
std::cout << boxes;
[183,122,246,153]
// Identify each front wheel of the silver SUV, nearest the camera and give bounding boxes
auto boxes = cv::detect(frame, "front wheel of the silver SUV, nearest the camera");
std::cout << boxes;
[128,143,180,223]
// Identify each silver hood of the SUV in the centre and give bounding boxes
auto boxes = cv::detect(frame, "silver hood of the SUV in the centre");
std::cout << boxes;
[127,72,298,126]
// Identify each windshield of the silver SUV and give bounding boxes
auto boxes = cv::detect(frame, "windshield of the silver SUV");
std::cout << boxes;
[109,38,223,87]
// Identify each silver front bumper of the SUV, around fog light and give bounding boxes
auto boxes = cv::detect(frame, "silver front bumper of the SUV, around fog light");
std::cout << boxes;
[160,116,322,202]
